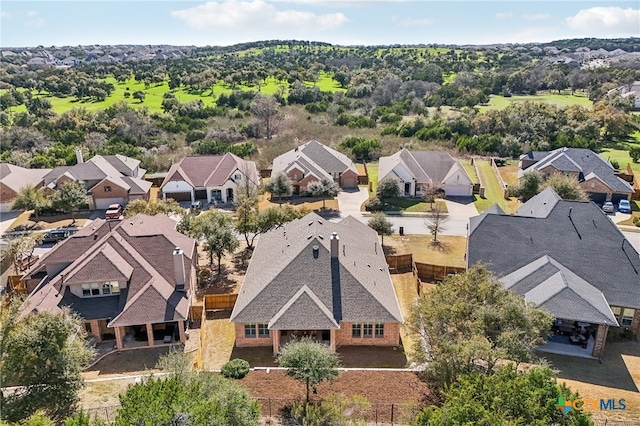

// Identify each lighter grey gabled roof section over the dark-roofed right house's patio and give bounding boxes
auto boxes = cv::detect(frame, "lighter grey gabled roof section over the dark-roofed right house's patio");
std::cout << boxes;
[500,255,618,326]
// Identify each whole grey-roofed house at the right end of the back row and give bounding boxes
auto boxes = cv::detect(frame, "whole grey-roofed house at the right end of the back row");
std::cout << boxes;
[518,147,633,204]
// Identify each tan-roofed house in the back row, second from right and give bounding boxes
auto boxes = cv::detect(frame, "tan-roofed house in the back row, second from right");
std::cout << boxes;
[378,148,473,197]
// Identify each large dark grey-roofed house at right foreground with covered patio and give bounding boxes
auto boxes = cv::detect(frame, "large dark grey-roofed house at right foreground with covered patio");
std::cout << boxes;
[467,188,640,358]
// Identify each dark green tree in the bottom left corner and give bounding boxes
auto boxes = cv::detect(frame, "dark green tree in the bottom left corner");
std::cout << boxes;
[0,303,93,421]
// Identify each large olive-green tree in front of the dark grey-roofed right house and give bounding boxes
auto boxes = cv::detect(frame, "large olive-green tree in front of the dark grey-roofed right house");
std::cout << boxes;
[407,265,552,389]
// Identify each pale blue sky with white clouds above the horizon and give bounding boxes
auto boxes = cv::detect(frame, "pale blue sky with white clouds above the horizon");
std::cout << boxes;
[0,0,640,47]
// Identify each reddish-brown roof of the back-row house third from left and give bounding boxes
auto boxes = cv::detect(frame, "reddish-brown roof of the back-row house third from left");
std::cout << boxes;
[160,153,258,188]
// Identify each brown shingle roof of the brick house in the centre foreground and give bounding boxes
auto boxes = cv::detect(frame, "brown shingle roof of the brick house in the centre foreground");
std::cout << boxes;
[231,213,402,329]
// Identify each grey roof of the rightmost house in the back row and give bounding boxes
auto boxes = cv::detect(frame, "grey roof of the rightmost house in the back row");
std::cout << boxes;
[518,147,633,193]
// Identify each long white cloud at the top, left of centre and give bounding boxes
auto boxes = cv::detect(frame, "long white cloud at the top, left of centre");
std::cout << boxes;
[171,0,348,31]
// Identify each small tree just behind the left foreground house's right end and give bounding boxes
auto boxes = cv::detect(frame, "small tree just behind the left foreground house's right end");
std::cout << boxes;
[188,211,240,274]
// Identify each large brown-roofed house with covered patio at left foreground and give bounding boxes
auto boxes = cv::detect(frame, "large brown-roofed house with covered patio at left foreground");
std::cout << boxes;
[22,215,198,349]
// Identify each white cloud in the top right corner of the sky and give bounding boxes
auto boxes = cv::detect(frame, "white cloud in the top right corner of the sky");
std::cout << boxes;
[566,7,640,36]
